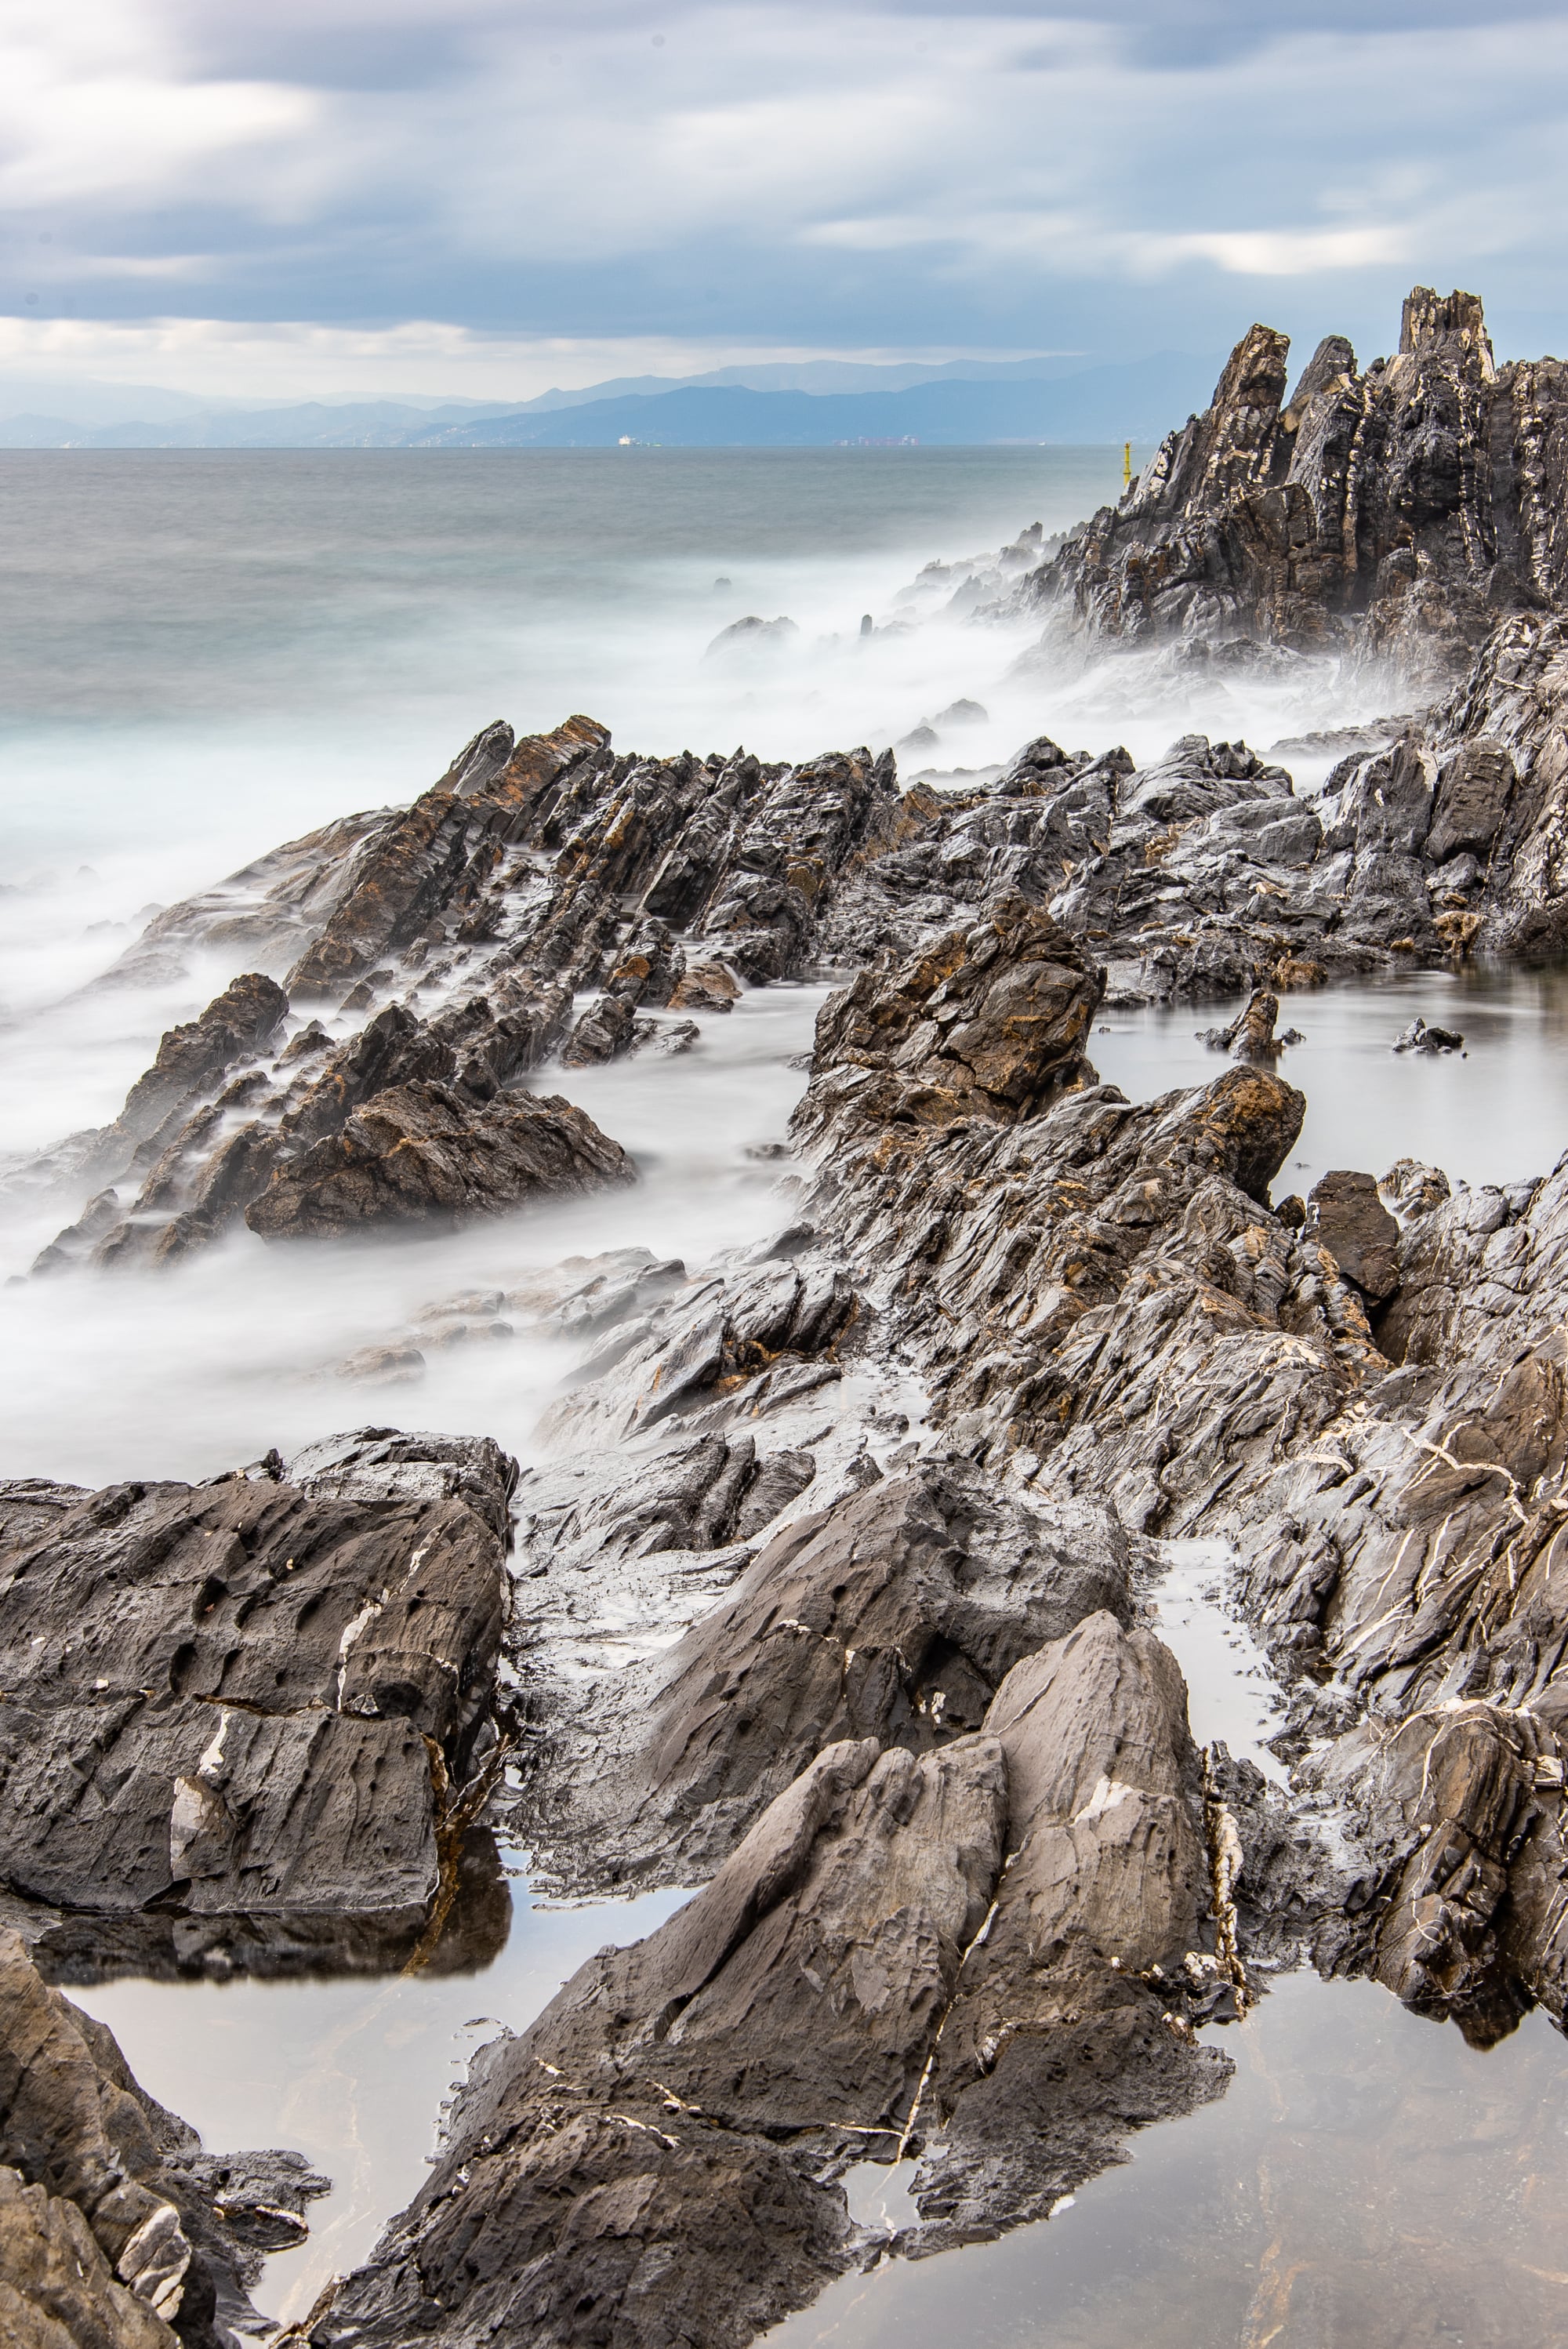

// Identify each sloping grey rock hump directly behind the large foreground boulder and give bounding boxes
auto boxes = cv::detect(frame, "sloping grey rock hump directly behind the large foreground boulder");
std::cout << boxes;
[512,1436,1131,1889]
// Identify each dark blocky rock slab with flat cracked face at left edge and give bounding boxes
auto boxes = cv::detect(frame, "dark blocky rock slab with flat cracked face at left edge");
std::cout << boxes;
[0,1431,517,1971]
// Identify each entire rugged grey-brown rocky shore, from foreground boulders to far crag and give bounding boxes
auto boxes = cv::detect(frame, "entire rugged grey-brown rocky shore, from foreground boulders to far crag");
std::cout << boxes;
[0,289,1568,2349]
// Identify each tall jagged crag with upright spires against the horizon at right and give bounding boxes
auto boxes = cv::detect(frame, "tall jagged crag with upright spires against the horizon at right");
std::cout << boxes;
[1021,287,1568,684]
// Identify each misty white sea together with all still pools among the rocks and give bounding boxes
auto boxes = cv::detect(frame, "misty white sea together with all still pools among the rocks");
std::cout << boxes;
[0,446,1568,2349]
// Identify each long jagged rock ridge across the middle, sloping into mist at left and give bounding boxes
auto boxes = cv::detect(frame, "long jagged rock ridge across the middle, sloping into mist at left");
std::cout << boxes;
[33,695,1556,1271]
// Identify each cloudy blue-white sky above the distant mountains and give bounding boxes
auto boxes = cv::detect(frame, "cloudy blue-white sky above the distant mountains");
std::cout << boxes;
[0,0,1568,399]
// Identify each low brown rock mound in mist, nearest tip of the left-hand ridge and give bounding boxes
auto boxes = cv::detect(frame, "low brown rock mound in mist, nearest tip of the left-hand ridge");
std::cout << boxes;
[244,1083,636,1240]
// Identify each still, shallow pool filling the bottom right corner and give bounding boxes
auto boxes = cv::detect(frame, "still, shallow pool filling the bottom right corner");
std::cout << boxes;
[768,1973,1568,2349]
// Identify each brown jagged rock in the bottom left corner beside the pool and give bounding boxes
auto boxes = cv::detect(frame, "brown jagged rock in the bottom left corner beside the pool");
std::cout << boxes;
[0,1931,328,2349]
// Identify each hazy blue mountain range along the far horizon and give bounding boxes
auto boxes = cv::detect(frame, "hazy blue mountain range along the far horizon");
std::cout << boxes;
[0,350,1221,448]
